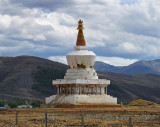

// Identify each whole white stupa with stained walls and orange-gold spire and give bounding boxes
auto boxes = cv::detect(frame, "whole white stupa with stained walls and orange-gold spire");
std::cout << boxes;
[46,20,117,107]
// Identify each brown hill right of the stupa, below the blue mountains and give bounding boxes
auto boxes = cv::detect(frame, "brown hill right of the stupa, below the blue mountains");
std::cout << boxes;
[99,72,160,102]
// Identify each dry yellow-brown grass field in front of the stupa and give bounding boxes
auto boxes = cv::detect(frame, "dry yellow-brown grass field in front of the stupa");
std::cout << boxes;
[0,103,160,127]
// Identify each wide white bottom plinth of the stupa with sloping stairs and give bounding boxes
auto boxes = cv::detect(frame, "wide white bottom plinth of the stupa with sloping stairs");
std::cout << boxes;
[46,94,117,108]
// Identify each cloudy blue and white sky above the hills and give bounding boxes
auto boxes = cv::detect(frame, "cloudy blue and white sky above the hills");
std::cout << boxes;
[0,0,160,66]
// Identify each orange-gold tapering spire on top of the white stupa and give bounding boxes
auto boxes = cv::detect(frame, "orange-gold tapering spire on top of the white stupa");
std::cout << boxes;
[76,19,86,46]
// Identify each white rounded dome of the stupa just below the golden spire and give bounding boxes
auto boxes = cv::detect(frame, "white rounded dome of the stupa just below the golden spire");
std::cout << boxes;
[66,46,96,68]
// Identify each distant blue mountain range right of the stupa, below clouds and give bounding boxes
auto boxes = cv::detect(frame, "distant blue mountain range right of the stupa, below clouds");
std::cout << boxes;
[94,59,160,74]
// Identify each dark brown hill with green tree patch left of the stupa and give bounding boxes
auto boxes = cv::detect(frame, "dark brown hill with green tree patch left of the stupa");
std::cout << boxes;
[0,56,67,100]
